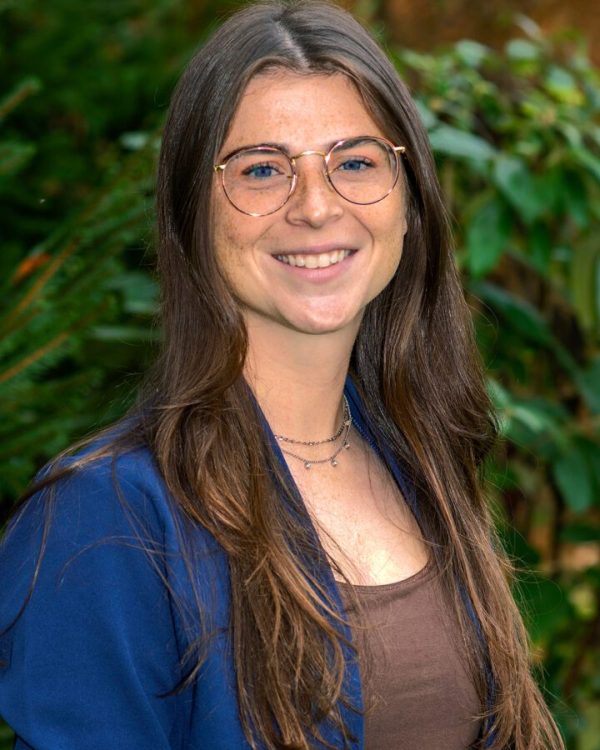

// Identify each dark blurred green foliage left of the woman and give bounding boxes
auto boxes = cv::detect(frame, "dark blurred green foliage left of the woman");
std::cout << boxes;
[0,0,238,526]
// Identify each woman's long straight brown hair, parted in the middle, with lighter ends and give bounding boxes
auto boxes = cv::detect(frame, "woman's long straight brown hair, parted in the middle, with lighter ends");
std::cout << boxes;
[17,2,562,750]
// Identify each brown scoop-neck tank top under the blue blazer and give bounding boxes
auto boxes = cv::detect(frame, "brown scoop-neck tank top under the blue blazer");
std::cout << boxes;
[338,559,481,750]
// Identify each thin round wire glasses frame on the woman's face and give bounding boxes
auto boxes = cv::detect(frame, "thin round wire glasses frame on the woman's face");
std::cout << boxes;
[214,135,406,217]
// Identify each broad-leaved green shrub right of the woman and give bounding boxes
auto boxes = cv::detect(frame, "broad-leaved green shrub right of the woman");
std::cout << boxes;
[397,19,600,750]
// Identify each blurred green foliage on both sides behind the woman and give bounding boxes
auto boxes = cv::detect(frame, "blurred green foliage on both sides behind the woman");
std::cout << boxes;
[0,0,600,750]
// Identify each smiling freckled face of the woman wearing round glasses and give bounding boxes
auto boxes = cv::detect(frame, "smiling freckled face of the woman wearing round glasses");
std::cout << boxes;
[213,70,406,338]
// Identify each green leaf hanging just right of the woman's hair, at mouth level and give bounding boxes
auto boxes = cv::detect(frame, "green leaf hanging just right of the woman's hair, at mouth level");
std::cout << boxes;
[466,198,512,277]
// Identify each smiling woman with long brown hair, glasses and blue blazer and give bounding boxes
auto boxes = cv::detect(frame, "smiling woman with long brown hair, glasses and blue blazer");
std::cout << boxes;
[0,2,562,750]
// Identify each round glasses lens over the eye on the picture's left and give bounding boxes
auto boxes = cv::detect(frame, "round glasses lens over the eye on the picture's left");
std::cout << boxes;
[223,147,293,216]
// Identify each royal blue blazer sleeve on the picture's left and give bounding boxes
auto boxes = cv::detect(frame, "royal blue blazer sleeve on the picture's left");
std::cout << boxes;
[0,459,190,750]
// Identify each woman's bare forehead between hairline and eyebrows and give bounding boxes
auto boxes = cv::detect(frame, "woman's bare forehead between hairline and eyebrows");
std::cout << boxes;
[221,70,385,153]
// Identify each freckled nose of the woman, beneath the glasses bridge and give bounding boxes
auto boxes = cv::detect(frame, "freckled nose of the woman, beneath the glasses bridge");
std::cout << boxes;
[287,151,344,227]
